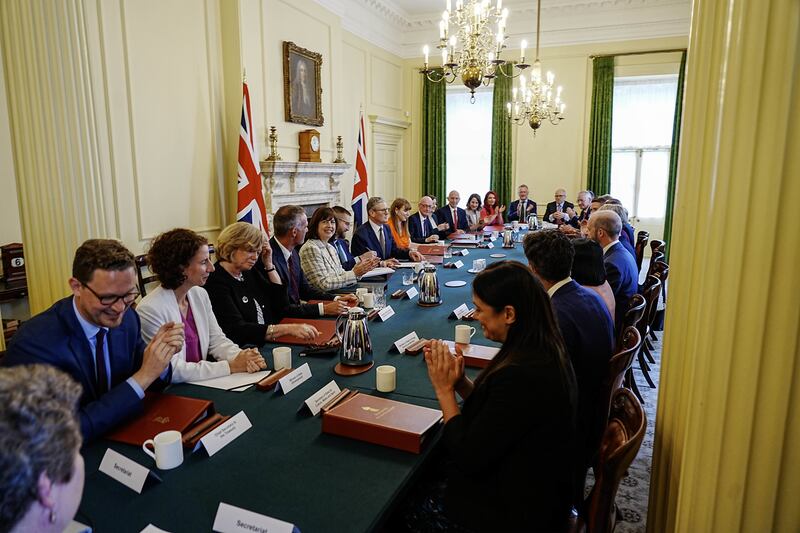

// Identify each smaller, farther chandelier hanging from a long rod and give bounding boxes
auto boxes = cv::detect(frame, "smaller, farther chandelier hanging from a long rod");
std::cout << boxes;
[506,0,567,132]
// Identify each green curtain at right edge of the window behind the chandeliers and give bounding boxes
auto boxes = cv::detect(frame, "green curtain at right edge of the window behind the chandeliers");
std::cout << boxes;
[489,76,514,204]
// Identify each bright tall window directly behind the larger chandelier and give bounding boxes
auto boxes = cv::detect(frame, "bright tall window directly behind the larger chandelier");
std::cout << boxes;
[439,85,492,200]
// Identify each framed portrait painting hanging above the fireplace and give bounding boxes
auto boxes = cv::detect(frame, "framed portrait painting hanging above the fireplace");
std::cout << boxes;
[283,41,324,126]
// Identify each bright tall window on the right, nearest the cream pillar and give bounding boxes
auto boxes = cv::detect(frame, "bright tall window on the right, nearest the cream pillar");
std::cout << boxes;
[611,75,678,220]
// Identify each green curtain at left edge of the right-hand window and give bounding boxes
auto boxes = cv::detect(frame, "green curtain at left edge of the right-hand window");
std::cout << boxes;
[586,56,614,196]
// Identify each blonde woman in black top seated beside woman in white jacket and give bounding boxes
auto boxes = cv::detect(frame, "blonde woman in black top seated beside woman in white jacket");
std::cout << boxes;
[205,222,319,346]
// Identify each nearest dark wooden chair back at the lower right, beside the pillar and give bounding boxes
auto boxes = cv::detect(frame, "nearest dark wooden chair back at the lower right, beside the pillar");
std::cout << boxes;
[575,388,647,533]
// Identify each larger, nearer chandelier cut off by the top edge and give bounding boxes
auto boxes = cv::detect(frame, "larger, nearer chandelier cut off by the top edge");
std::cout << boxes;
[420,0,530,103]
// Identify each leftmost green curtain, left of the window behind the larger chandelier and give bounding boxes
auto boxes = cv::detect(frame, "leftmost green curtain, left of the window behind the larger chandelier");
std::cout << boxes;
[422,69,447,206]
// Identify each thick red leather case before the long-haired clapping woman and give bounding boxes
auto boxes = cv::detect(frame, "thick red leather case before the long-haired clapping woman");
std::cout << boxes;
[322,394,442,453]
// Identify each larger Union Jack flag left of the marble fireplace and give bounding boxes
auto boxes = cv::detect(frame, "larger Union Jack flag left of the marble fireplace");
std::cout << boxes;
[236,83,269,231]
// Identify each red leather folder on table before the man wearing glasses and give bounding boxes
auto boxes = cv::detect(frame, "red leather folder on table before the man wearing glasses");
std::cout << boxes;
[106,392,217,446]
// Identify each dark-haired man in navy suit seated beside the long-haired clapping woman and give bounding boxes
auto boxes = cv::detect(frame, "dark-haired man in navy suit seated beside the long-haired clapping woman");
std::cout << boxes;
[524,230,614,502]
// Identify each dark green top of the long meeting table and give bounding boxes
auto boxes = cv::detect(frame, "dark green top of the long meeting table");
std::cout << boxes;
[76,237,525,533]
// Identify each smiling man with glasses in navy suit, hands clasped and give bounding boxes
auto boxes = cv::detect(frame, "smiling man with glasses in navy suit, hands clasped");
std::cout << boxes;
[3,239,183,442]
